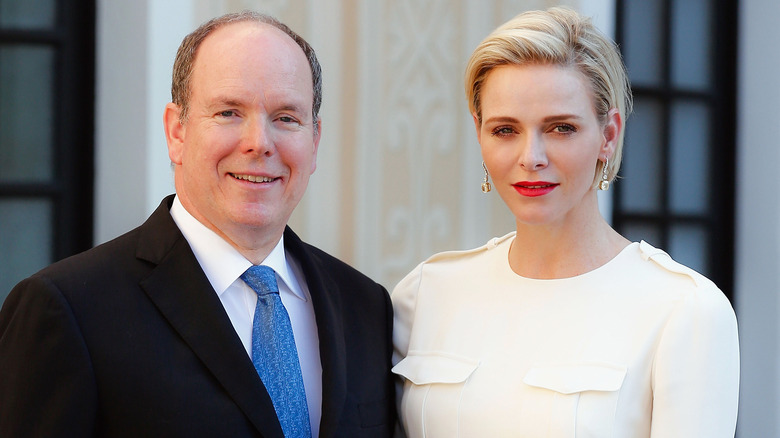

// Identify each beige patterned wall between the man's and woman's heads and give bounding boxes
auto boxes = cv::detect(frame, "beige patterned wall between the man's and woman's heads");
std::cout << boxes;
[196,0,576,288]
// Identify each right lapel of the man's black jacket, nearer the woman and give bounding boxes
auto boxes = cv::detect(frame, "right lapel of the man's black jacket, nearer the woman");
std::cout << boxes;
[284,227,347,438]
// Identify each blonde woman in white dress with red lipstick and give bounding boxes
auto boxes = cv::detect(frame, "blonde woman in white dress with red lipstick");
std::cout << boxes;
[392,8,739,438]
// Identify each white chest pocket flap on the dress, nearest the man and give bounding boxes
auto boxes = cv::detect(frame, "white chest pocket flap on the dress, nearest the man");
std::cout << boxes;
[393,351,479,385]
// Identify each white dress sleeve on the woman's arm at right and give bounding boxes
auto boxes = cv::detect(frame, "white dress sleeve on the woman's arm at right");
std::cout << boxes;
[651,282,739,438]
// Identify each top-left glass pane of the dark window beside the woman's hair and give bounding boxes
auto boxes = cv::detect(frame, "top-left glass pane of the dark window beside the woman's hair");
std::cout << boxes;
[621,0,664,86]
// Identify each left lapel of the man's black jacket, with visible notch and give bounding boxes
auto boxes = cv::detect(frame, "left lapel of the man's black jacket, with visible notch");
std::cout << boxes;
[137,196,283,438]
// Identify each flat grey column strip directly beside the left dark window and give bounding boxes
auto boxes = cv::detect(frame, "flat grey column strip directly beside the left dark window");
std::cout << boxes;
[94,0,148,243]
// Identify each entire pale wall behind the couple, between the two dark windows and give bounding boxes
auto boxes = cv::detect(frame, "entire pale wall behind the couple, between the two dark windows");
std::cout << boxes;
[96,0,596,289]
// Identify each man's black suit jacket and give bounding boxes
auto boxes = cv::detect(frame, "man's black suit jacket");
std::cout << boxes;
[0,196,395,438]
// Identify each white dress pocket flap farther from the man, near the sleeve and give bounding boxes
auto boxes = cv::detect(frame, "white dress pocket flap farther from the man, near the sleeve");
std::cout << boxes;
[523,362,626,394]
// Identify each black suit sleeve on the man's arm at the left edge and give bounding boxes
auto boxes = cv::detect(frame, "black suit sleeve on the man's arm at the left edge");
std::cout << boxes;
[0,277,97,437]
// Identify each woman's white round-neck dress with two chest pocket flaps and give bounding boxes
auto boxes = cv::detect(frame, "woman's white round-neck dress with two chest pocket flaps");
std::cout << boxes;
[392,233,739,438]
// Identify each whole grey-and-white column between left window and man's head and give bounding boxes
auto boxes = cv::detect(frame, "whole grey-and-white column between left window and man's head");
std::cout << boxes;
[94,0,195,244]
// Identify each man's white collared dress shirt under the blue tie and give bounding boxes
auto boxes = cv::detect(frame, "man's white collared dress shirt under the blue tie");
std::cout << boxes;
[171,196,322,437]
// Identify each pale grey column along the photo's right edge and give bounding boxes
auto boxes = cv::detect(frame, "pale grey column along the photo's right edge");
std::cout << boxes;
[735,0,780,437]
